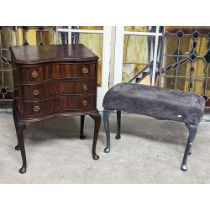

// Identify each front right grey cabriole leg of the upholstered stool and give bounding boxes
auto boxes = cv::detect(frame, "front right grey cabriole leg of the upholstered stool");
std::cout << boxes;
[181,124,197,171]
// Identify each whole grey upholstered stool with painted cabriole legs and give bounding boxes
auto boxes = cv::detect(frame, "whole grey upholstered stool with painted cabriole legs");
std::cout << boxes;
[103,83,205,171]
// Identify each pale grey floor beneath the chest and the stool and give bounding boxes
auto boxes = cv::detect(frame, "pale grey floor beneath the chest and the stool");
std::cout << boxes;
[0,112,210,183]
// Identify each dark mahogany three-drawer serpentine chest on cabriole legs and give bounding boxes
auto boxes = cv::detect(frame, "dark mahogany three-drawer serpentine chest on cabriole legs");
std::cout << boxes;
[10,45,101,173]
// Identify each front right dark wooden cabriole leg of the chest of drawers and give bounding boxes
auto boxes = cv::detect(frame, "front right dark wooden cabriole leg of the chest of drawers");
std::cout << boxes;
[90,111,101,160]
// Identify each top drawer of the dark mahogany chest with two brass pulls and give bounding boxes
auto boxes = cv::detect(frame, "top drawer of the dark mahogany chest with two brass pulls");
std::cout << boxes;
[20,63,97,82]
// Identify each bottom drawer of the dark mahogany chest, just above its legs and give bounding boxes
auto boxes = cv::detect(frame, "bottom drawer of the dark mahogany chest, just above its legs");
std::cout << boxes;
[21,95,96,118]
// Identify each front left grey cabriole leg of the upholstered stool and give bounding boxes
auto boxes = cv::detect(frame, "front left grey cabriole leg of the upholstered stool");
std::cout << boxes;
[103,109,112,153]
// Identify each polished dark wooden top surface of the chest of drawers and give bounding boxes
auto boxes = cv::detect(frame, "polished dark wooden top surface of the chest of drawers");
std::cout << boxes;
[10,44,98,64]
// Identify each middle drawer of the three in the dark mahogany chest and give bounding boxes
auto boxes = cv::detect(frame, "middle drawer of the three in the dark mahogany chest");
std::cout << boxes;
[21,79,96,99]
